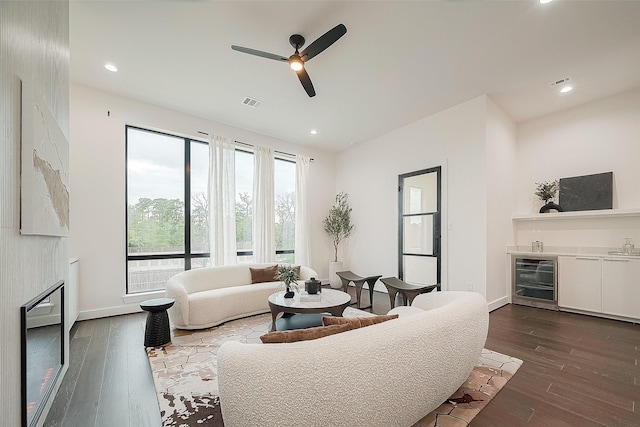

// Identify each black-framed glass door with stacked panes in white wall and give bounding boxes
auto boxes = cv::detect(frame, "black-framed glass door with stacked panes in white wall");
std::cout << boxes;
[398,166,442,290]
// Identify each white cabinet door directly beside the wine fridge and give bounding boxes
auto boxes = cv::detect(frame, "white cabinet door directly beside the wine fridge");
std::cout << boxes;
[558,257,602,313]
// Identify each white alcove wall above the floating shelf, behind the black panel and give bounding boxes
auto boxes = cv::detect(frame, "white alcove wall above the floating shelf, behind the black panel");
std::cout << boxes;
[516,89,640,214]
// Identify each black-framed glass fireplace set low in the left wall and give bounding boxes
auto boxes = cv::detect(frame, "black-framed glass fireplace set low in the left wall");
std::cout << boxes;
[20,280,65,427]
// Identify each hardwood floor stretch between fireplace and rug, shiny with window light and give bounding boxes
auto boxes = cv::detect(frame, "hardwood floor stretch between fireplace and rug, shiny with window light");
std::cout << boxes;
[44,313,162,427]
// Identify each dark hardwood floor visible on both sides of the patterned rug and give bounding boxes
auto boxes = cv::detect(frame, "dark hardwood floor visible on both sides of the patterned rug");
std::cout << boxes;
[44,290,640,427]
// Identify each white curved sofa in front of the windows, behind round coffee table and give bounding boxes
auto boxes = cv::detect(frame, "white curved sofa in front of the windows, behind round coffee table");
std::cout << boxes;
[165,263,317,329]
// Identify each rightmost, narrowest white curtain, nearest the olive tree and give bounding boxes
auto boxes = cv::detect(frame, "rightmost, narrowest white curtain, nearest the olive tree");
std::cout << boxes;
[295,156,311,266]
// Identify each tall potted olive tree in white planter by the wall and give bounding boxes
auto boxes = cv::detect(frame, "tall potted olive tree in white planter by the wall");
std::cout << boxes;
[322,193,353,289]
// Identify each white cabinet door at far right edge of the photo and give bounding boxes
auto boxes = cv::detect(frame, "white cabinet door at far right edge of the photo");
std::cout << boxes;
[602,258,640,319]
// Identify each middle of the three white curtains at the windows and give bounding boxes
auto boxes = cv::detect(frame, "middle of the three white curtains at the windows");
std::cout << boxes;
[253,147,276,262]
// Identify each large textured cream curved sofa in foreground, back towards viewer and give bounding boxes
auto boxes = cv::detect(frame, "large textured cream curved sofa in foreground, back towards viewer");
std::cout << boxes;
[217,292,489,427]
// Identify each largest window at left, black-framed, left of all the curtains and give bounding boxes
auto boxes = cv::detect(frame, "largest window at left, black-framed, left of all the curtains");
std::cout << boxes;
[126,126,209,293]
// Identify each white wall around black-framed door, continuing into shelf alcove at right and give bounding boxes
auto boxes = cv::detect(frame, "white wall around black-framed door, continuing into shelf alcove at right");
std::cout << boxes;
[337,90,640,308]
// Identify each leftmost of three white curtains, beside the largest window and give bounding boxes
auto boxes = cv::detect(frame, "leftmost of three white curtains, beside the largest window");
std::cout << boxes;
[209,135,237,265]
